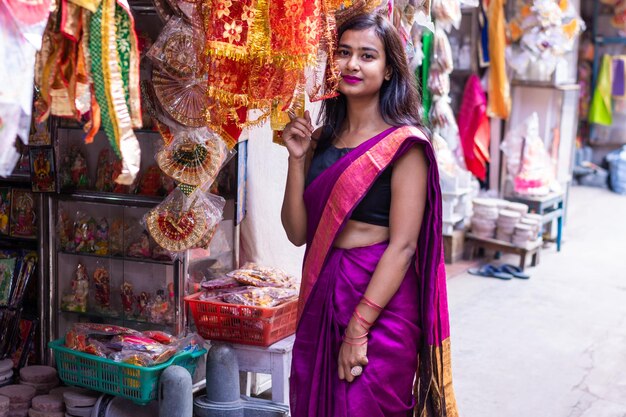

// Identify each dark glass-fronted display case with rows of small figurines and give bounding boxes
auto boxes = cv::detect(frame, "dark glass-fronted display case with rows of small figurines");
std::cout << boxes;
[48,122,186,352]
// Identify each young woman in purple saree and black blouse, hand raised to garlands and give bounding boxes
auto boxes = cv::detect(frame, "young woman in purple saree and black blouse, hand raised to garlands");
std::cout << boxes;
[282,11,457,417]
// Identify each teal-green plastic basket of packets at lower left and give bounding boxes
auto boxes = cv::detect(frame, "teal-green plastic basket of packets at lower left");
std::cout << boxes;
[48,338,207,405]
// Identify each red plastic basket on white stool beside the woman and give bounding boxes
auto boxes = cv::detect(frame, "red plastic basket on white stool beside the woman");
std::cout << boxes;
[185,292,298,346]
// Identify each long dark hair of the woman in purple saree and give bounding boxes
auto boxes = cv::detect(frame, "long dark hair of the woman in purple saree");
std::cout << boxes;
[320,13,422,148]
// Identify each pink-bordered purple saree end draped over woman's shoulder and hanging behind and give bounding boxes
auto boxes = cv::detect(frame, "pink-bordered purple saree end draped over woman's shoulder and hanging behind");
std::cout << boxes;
[298,126,458,417]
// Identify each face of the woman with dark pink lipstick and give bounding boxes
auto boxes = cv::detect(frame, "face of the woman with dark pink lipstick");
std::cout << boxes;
[336,28,391,97]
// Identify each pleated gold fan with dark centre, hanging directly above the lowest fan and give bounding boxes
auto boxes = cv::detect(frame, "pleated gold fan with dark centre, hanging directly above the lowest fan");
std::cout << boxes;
[155,127,234,186]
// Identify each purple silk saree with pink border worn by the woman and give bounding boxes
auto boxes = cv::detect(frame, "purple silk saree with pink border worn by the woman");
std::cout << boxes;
[290,126,458,417]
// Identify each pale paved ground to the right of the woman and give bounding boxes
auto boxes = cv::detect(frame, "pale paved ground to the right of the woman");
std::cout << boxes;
[448,187,626,417]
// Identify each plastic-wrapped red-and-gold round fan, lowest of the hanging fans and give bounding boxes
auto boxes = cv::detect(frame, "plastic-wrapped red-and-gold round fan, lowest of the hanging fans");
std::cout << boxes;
[142,189,225,253]
